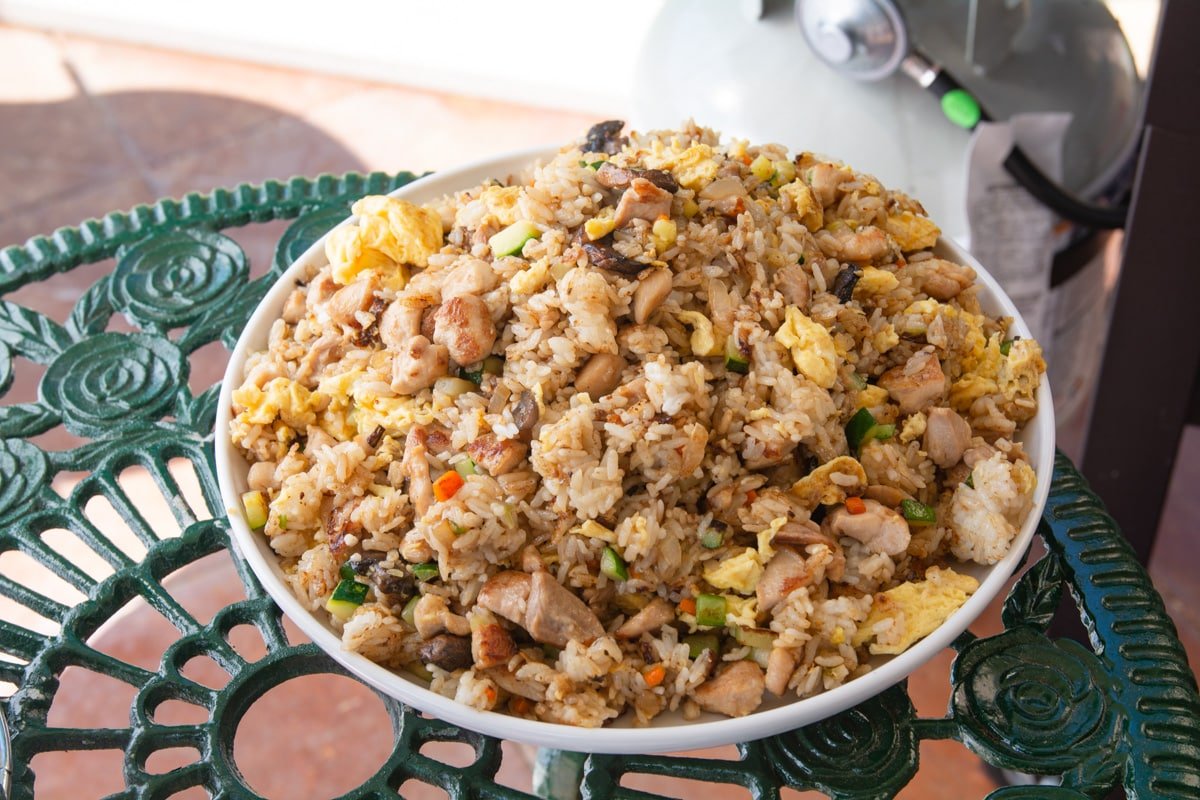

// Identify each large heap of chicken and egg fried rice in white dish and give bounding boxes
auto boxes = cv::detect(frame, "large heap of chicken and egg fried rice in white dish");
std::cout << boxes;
[229,121,1045,726]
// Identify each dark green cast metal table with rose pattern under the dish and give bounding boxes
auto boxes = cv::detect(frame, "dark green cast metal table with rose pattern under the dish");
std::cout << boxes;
[0,173,1200,800]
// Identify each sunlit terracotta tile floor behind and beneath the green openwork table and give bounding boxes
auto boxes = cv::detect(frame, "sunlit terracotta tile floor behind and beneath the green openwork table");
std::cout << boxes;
[0,26,1200,800]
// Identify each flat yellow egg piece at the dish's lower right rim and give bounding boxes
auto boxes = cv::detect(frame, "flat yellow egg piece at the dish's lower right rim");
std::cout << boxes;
[853,566,979,655]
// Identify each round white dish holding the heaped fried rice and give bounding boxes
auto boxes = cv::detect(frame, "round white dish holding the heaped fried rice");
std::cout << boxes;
[216,148,1055,753]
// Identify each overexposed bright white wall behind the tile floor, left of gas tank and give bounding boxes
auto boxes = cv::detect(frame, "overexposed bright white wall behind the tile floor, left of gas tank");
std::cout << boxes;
[0,0,662,113]
